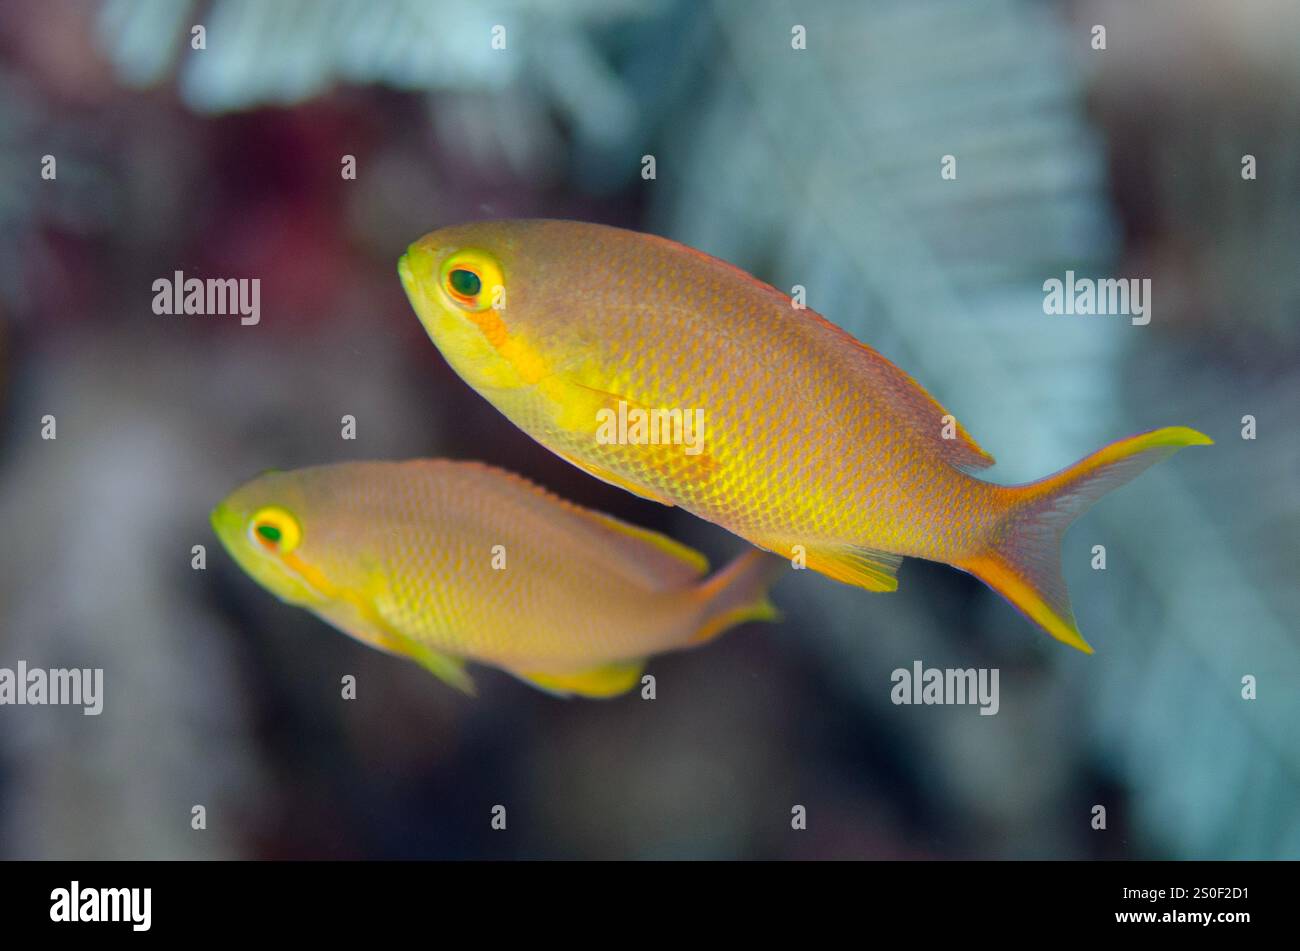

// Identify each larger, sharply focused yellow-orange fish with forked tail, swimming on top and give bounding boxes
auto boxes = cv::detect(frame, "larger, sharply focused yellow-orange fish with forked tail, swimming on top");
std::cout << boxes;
[398,221,1213,652]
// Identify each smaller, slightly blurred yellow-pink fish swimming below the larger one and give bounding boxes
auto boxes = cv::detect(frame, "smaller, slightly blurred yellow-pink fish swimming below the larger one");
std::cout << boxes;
[212,460,785,696]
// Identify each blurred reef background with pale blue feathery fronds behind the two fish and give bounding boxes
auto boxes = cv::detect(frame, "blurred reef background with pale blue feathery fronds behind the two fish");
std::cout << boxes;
[0,0,1300,859]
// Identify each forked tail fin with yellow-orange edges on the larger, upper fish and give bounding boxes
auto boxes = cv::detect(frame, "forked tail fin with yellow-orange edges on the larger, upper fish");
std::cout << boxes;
[957,426,1214,653]
